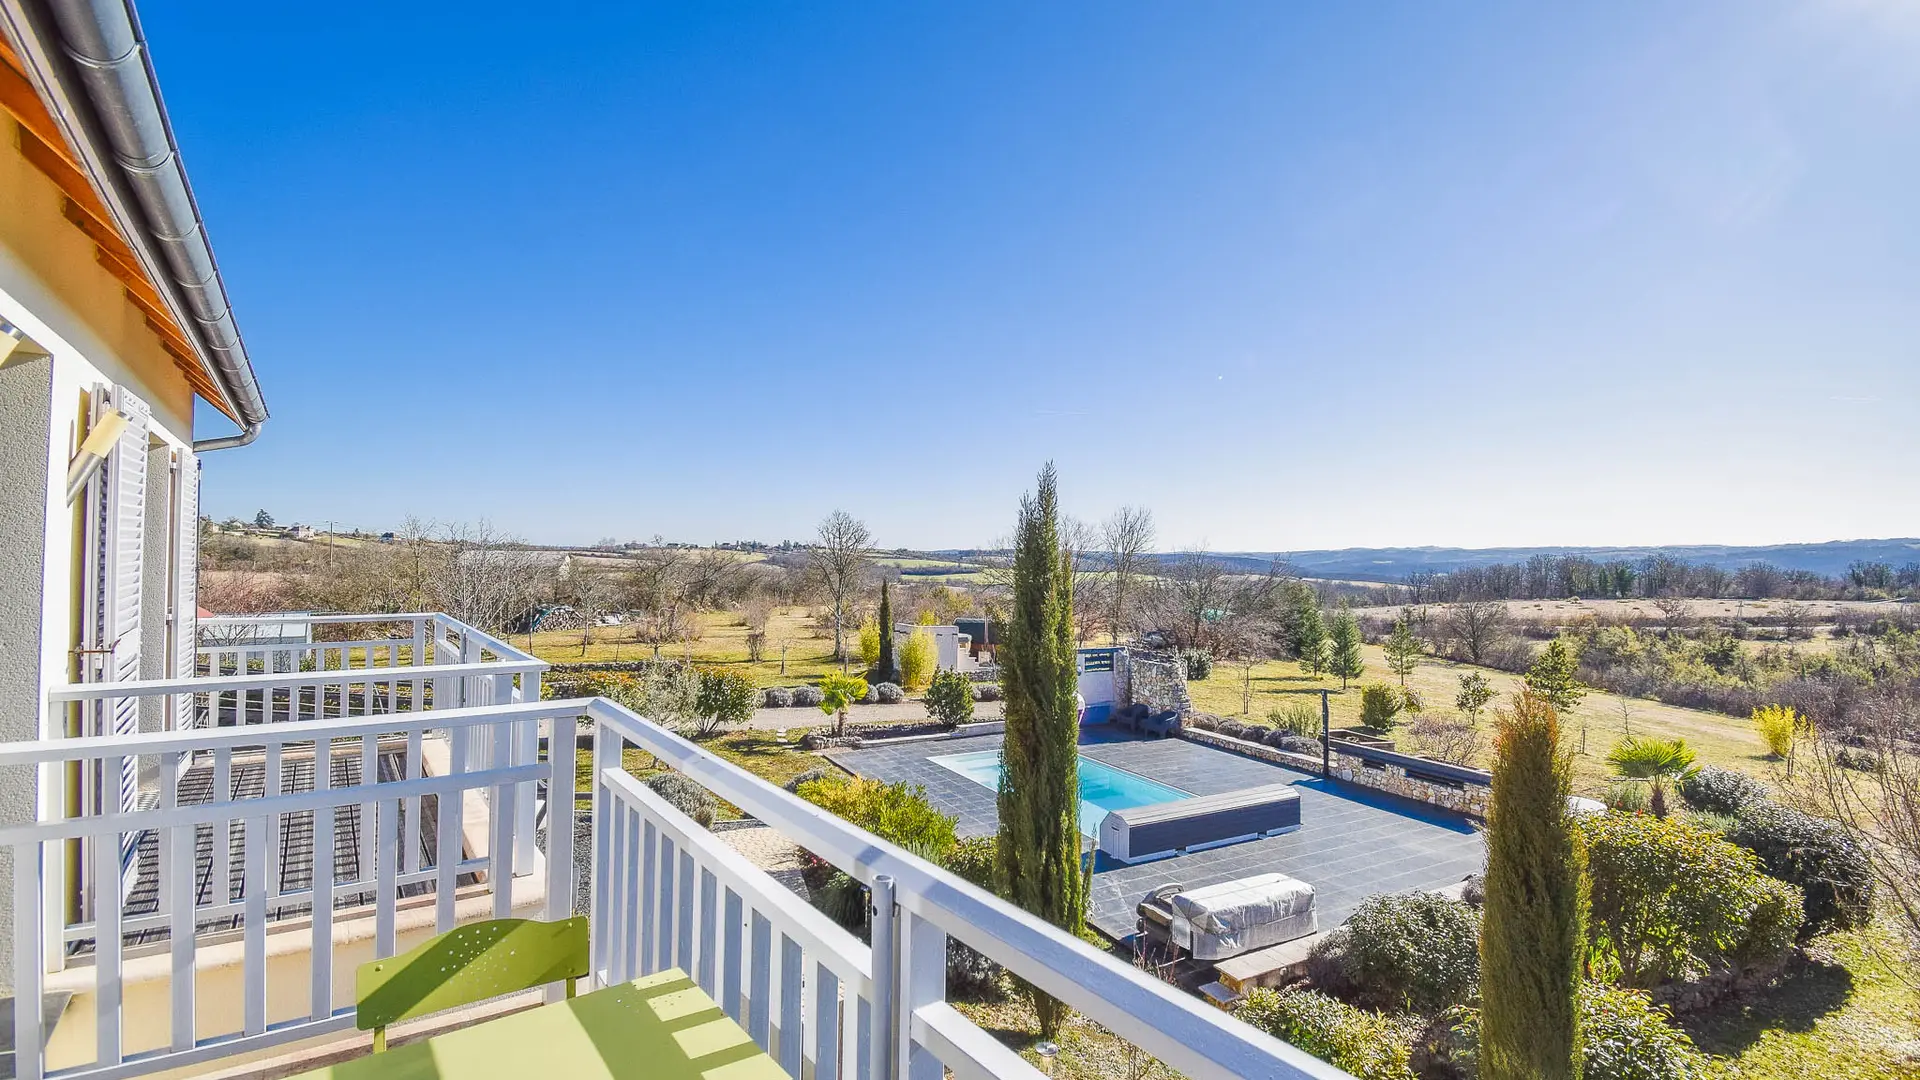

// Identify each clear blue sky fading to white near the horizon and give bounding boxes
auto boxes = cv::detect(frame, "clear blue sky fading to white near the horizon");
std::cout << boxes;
[153,0,1920,550]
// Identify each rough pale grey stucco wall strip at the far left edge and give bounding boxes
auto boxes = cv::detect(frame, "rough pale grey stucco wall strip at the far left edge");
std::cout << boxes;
[0,357,54,990]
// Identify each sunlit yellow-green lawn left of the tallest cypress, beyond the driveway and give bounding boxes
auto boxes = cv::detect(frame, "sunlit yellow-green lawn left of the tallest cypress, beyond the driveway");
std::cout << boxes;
[529,607,858,686]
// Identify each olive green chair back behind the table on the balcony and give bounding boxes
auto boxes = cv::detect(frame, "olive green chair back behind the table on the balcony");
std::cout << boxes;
[353,915,591,1053]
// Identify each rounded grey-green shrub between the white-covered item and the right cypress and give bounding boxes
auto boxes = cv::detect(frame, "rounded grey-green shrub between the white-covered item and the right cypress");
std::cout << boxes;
[1308,892,1480,1013]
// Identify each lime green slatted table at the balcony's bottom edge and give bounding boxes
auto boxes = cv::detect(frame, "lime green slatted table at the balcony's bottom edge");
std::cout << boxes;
[300,969,787,1080]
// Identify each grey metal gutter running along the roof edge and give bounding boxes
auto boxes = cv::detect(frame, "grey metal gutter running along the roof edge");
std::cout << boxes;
[48,0,267,428]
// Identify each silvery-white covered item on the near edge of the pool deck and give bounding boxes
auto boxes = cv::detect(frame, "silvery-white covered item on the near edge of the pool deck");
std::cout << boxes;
[1137,874,1319,961]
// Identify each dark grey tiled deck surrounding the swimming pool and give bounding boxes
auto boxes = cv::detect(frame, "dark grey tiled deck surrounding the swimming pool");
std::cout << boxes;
[828,730,1486,938]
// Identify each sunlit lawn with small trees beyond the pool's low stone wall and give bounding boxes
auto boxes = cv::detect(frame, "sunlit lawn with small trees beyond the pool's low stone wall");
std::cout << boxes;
[1187,646,1772,794]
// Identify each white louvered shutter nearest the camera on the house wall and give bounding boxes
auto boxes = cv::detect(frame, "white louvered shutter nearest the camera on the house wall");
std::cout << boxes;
[83,386,152,811]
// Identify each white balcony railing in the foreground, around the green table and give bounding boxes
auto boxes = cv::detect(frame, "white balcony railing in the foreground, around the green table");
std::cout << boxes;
[0,684,1344,1080]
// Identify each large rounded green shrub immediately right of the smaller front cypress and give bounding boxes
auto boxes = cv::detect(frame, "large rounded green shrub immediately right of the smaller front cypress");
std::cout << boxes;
[1578,813,1801,986]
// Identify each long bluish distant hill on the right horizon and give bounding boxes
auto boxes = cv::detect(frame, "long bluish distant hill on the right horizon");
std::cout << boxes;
[1190,538,1920,582]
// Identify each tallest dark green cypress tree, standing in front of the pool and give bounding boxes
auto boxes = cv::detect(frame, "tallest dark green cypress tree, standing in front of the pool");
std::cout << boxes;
[995,461,1087,1038]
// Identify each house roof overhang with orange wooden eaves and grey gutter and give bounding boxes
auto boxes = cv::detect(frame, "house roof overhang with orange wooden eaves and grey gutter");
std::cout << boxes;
[0,0,267,428]
